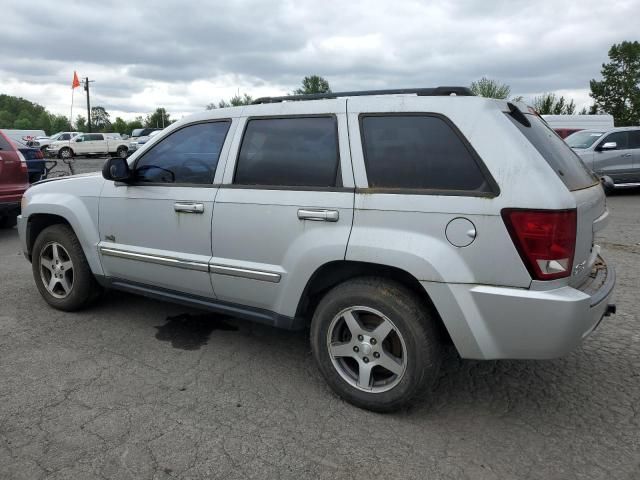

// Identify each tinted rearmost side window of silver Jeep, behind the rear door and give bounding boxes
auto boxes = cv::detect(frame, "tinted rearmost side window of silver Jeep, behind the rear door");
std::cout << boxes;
[360,115,492,192]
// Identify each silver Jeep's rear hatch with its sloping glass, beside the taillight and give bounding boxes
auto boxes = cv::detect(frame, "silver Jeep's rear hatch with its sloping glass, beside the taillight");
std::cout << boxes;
[507,107,608,286]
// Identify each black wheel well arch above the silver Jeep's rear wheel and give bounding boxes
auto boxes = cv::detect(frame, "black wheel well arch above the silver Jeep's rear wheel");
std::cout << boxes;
[296,261,453,344]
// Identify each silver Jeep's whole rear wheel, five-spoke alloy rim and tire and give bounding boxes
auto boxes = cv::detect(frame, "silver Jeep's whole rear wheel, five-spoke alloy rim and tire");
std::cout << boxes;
[311,277,442,412]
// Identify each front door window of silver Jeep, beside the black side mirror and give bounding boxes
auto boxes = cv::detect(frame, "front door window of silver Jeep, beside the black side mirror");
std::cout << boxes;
[135,120,231,184]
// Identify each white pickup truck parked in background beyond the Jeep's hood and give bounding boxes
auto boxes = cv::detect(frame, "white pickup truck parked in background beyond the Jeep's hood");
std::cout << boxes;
[47,133,129,159]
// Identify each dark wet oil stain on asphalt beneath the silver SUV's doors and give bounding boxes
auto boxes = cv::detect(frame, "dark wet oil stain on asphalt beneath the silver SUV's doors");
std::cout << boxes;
[155,313,238,350]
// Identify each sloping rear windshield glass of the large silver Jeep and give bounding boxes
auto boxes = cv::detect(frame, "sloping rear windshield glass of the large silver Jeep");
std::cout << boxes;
[507,114,598,190]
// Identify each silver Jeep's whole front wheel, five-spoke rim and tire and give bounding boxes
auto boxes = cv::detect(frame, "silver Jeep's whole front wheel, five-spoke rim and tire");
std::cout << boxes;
[32,225,101,311]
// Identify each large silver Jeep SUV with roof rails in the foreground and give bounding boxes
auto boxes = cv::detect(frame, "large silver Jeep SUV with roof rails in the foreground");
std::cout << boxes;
[19,87,615,411]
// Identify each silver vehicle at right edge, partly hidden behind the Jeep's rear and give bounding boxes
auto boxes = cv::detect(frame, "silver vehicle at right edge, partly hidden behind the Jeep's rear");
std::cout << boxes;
[566,127,640,193]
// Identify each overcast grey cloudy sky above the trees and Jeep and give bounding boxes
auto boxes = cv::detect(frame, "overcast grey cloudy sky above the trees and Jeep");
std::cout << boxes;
[0,0,640,120]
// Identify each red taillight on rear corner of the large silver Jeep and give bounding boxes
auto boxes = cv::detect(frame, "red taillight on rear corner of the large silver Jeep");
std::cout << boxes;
[502,208,577,280]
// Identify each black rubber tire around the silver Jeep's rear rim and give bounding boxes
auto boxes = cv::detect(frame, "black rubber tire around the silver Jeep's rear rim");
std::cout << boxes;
[311,277,442,412]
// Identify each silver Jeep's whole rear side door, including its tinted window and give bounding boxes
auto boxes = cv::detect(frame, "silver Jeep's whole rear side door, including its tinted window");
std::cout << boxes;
[211,100,354,318]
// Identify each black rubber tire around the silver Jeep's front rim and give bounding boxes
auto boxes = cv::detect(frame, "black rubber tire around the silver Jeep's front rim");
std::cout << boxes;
[31,224,102,312]
